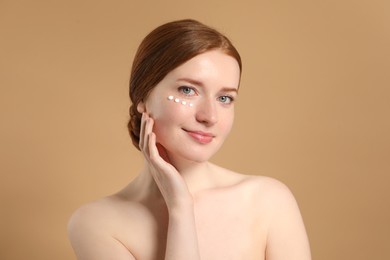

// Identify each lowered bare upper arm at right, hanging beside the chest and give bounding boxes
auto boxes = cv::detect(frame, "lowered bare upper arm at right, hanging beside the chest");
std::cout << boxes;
[266,180,311,260]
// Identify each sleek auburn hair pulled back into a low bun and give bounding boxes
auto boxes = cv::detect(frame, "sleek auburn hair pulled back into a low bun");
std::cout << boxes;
[127,19,242,150]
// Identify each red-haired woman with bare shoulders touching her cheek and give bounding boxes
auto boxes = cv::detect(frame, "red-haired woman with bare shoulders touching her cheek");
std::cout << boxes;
[69,20,310,260]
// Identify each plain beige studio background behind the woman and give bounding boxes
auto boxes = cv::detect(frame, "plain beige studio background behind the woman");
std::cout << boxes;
[0,0,390,260]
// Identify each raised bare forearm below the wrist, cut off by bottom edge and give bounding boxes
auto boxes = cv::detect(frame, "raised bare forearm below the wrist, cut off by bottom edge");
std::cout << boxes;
[165,204,200,260]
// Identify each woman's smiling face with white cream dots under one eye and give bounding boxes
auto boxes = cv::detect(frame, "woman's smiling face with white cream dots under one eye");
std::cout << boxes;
[138,50,240,162]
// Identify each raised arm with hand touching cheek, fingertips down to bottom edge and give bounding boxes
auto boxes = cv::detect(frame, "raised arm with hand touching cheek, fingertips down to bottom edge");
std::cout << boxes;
[140,114,200,260]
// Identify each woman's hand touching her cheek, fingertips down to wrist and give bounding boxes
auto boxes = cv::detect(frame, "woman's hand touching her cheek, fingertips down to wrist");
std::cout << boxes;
[139,113,193,211]
